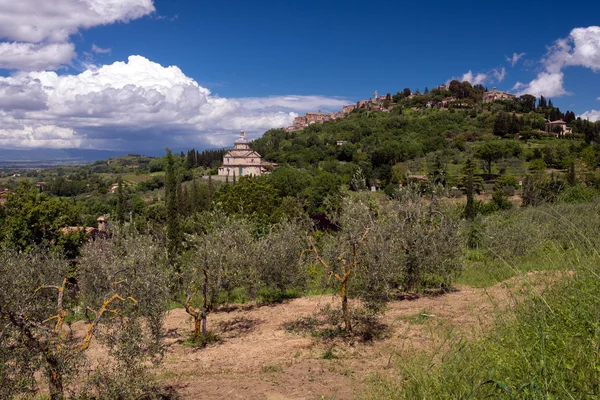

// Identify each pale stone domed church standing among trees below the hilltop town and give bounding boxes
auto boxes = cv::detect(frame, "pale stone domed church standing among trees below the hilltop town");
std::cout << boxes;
[219,131,276,177]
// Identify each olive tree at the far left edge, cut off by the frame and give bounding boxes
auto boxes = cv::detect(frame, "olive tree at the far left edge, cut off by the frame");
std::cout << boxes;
[0,247,74,399]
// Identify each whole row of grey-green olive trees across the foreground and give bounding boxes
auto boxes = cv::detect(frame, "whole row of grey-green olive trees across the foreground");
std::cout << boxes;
[0,188,461,399]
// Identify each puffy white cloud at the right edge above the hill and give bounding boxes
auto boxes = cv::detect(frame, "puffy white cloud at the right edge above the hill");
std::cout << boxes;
[515,26,600,97]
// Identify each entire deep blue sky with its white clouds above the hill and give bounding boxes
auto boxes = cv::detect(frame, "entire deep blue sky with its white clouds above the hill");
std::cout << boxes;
[0,0,600,149]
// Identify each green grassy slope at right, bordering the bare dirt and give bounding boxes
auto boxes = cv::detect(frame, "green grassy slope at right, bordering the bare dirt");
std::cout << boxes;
[366,203,600,399]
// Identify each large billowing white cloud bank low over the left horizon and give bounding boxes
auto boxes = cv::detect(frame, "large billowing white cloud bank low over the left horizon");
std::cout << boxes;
[0,56,348,150]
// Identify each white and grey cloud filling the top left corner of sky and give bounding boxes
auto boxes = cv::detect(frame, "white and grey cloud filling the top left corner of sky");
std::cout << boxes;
[0,0,155,71]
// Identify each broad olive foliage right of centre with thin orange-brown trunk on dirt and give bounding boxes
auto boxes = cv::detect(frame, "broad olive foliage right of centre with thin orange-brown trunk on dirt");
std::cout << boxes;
[311,193,462,331]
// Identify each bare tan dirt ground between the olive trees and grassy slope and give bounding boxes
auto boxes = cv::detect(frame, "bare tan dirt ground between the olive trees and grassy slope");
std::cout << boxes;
[158,274,538,400]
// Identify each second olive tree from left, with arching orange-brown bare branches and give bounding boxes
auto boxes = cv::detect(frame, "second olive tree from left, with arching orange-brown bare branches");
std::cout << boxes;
[77,233,169,398]
